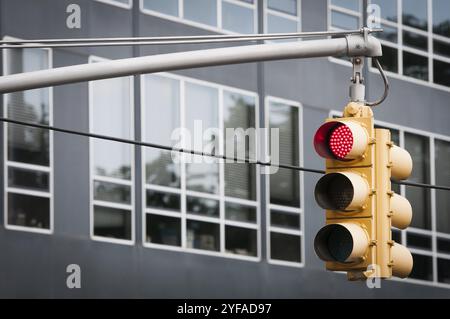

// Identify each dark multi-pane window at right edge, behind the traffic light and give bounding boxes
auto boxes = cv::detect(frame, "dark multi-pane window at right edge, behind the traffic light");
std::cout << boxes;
[332,112,450,287]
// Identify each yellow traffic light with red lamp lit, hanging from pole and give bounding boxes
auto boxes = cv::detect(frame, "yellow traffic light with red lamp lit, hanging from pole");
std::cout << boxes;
[314,102,412,280]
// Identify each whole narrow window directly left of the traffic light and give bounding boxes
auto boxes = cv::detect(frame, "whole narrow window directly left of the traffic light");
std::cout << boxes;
[266,97,304,265]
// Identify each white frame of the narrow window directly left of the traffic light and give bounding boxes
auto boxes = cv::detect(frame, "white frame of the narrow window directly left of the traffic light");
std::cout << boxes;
[264,95,305,268]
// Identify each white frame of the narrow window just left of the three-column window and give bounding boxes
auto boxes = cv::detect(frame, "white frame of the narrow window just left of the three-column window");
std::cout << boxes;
[88,55,136,246]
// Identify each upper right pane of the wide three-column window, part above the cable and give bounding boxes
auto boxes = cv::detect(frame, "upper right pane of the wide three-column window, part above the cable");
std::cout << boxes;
[223,91,256,158]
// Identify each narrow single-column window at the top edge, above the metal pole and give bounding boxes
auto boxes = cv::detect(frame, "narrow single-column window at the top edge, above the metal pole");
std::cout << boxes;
[264,0,300,41]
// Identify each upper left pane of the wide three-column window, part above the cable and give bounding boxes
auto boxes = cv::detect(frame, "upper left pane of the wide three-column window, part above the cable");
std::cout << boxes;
[143,75,180,146]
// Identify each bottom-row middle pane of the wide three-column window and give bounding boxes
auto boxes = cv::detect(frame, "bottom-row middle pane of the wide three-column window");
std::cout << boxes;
[186,220,220,251]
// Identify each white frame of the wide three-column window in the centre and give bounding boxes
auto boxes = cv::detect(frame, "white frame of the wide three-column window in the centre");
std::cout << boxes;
[140,72,262,262]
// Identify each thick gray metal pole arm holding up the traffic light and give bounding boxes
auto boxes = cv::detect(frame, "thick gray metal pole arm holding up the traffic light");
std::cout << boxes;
[0,35,382,93]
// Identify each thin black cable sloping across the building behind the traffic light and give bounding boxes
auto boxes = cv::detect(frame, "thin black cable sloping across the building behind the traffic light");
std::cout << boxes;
[0,117,450,191]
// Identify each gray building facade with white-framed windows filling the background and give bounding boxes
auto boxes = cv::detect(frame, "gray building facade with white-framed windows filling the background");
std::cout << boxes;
[0,0,450,298]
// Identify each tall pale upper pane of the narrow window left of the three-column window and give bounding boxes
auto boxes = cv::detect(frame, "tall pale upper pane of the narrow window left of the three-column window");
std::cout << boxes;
[90,77,134,179]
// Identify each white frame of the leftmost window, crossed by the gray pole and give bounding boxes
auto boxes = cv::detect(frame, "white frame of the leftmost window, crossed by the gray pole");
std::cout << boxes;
[2,36,55,235]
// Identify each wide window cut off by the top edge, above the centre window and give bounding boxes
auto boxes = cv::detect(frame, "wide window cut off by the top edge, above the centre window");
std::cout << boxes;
[141,0,257,33]
